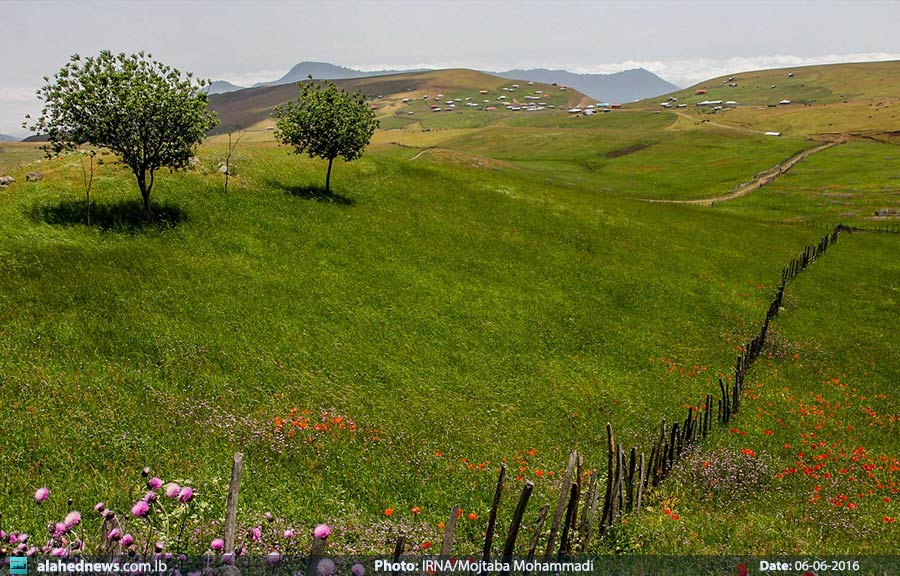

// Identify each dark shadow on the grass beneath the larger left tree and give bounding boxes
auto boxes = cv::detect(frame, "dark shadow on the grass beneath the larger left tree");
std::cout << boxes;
[28,200,187,234]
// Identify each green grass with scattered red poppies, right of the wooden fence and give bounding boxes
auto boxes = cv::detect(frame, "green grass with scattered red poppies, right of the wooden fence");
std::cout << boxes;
[618,234,900,555]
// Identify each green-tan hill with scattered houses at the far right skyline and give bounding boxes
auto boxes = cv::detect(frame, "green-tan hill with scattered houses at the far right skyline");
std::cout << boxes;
[639,61,900,140]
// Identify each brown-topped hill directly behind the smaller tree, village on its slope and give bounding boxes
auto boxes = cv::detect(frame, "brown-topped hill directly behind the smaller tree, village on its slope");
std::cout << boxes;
[210,69,590,133]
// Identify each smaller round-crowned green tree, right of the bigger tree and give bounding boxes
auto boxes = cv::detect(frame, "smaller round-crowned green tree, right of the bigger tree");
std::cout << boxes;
[272,82,378,194]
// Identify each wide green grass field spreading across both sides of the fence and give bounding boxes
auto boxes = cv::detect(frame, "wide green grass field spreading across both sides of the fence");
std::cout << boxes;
[0,63,898,554]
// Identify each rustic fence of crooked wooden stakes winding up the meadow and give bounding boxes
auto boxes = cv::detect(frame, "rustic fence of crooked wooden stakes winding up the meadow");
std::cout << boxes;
[207,225,852,569]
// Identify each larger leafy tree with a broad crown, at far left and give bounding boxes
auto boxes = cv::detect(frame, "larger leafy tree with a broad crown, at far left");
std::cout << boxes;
[30,50,218,217]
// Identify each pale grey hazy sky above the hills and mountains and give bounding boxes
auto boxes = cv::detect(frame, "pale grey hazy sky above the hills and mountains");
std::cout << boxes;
[0,0,900,136]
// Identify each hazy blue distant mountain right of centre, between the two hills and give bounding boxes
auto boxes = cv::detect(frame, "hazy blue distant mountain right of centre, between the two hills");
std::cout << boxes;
[491,68,680,102]
